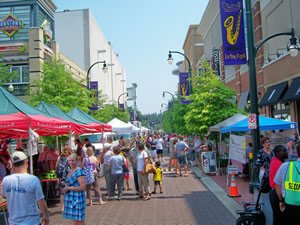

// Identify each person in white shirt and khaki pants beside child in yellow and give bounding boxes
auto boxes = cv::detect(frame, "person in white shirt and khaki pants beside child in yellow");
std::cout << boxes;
[137,143,150,200]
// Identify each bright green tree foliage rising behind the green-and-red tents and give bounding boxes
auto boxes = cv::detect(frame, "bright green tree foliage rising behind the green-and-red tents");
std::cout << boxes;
[29,60,95,112]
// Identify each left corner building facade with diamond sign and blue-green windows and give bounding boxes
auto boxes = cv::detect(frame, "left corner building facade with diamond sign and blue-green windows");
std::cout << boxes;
[0,0,86,98]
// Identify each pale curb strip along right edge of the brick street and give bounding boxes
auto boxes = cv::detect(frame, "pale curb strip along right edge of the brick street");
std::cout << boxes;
[190,167,242,218]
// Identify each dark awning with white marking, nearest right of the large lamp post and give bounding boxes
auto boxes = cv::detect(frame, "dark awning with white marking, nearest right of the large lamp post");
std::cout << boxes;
[259,81,288,107]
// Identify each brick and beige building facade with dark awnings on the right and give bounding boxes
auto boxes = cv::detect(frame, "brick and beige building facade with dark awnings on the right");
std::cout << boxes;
[192,0,300,128]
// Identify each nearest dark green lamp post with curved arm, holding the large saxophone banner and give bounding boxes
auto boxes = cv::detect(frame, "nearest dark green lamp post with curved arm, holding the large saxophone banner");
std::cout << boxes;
[245,1,299,190]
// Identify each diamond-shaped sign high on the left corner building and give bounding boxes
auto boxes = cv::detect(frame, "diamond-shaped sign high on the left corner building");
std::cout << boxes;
[0,14,24,37]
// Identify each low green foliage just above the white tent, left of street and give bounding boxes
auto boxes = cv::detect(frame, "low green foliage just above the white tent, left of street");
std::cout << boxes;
[91,104,130,123]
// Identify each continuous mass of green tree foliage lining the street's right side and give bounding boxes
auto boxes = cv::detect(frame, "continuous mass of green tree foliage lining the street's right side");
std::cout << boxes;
[163,62,244,136]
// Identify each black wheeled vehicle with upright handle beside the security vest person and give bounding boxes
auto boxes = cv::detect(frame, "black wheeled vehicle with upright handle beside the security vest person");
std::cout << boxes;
[235,188,266,225]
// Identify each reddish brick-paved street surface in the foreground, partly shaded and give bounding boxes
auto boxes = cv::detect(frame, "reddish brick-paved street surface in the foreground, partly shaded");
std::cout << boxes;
[49,160,235,225]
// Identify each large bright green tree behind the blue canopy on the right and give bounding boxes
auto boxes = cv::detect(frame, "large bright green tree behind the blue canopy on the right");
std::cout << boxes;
[184,62,243,135]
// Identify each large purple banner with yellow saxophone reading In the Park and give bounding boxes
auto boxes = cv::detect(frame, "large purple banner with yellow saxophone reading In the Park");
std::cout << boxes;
[220,0,247,65]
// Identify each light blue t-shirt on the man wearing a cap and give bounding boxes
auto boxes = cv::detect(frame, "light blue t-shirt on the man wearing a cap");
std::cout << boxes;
[2,173,44,225]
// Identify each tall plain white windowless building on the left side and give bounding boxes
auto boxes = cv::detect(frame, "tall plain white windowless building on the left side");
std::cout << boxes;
[55,9,126,104]
